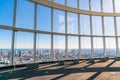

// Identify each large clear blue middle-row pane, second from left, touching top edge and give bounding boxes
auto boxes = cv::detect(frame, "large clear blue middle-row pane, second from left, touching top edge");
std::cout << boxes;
[16,0,35,29]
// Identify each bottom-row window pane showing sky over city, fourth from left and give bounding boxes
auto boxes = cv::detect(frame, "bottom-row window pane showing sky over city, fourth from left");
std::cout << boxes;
[53,35,66,60]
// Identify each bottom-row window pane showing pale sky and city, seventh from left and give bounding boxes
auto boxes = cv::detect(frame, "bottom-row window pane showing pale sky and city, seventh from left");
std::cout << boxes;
[93,37,104,58]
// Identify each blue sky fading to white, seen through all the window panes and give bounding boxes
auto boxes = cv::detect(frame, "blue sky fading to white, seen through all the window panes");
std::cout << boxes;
[0,0,120,48]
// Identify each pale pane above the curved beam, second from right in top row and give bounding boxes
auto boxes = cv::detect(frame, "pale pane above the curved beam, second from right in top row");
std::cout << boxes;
[103,0,113,12]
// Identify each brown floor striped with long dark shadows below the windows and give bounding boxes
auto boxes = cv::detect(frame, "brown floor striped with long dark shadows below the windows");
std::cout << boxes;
[0,59,120,80]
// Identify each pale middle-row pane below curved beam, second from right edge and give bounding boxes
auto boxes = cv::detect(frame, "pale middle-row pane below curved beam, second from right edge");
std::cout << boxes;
[104,17,115,35]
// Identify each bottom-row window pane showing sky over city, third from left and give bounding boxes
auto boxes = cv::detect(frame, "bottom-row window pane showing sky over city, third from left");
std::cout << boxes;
[36,34,51,62]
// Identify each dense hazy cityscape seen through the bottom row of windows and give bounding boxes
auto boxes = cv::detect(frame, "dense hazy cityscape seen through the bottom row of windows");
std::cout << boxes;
[0,49,116,67]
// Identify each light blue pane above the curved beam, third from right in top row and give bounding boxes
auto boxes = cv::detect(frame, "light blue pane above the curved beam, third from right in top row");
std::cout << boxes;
[91,0,101,12]
